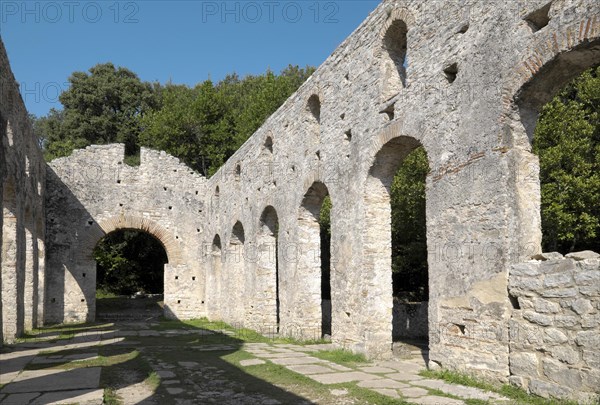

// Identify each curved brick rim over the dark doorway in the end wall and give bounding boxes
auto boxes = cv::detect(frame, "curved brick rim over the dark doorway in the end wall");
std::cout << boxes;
[80,214,183,267]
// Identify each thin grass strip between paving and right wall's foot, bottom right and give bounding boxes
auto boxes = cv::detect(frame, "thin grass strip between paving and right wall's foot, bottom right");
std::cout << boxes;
[419,370,577,405]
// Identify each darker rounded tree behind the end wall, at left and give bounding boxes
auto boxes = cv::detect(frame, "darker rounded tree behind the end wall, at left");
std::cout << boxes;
[39,63,157,160]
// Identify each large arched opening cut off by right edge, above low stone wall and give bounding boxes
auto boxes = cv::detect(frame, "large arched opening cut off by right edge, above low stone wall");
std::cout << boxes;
[513,39,600,260]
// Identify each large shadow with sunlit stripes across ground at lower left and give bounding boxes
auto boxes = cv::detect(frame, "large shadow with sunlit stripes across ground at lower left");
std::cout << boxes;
[0,321,311,405]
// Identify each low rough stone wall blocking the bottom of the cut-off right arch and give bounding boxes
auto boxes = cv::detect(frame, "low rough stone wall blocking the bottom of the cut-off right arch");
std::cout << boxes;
[509,251,600,401]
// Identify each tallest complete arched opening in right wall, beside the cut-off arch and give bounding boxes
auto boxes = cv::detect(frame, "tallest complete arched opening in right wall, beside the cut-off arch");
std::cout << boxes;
[365,136,429,354]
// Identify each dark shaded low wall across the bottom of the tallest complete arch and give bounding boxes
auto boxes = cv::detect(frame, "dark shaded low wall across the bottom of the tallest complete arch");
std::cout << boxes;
[392,300,429,340]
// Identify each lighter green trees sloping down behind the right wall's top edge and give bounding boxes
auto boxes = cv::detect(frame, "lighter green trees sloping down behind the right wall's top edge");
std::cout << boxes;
[140,66,314,176]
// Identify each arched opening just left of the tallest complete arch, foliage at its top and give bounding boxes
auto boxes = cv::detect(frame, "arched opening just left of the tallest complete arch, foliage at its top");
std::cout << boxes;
[298,181,333,337]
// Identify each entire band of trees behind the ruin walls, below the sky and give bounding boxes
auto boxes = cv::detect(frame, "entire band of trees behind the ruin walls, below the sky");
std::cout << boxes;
[33,63,314,176]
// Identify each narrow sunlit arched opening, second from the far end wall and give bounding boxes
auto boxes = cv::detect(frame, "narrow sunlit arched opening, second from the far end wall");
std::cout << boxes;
[226,221,246,327]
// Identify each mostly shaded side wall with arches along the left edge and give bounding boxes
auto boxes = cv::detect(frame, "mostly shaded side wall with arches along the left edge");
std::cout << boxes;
[0,40,46,345]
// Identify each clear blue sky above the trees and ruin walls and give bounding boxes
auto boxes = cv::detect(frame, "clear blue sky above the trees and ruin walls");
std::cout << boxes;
[0,0,379,116]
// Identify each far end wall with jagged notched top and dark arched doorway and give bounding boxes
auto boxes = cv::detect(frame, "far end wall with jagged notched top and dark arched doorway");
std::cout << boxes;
[46,144,206,323]
